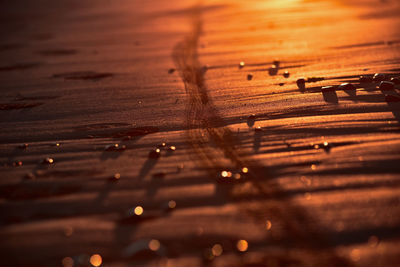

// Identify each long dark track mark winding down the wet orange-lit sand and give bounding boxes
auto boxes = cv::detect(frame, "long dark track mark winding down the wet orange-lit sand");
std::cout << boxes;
[172,5,352,266]
